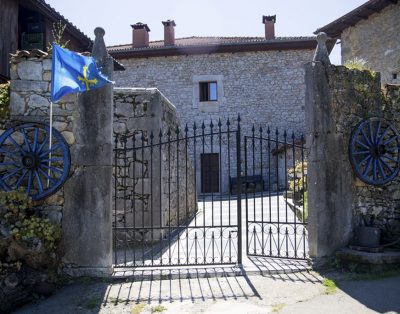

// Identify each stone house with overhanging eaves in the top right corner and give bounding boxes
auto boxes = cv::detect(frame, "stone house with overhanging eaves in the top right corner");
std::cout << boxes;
[315,0,400,84]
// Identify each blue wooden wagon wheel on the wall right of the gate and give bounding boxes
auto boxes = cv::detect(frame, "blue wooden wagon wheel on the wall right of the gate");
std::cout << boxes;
[349,118,400,185]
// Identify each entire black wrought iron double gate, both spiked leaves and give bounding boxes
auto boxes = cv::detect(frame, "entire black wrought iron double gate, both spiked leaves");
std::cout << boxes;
[113,117,307,267]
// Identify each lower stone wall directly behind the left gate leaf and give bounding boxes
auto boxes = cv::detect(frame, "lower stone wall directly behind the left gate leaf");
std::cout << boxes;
[114,88,197,245]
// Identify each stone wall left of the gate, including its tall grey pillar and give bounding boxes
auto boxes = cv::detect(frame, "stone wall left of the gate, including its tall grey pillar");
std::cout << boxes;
[7,28,113,276]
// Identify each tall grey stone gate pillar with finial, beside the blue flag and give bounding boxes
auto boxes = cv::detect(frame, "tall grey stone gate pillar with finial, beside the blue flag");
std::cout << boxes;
[62,28,113,276]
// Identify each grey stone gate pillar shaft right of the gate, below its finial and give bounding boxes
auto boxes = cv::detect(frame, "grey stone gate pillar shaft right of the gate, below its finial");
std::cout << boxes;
[306,62,353,260]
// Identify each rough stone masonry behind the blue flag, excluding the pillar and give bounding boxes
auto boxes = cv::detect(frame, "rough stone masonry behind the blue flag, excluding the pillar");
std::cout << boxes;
[6,55,77,225]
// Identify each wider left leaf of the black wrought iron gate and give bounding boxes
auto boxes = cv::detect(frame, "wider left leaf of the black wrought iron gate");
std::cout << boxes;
[113,119,242,267]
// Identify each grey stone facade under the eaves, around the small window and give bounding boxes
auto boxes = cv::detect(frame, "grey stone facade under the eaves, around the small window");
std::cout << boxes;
[115,49,313,193]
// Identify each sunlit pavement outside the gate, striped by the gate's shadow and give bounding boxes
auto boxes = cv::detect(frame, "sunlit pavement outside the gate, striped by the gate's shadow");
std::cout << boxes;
[16,272,400,314]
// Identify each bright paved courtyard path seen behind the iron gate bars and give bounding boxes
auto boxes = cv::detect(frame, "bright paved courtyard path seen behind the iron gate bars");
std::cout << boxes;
[114,194,308,266]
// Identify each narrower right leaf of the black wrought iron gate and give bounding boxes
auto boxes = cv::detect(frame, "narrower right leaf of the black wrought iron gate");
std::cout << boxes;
[244,128,308,259]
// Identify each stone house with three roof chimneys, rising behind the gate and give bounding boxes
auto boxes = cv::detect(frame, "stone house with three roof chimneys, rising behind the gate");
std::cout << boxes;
[108,16,334,193]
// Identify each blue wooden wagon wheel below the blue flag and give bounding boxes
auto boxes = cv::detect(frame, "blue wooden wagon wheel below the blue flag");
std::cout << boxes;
[0,123,71,200]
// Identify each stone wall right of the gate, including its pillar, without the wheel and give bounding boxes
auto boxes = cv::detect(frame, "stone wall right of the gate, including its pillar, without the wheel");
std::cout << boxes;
[306,62,400,258]
